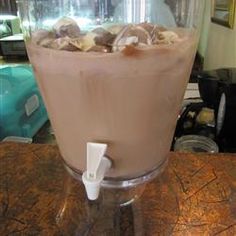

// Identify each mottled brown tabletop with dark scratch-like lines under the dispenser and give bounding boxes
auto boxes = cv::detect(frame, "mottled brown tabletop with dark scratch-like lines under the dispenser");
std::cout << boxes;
[0,143,236,236]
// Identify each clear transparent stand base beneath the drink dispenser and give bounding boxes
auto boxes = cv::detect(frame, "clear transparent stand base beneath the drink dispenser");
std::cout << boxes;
[56,166,179,236]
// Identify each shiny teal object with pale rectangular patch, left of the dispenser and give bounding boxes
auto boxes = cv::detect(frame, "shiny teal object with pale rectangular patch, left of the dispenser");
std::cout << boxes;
[0,65,48,140]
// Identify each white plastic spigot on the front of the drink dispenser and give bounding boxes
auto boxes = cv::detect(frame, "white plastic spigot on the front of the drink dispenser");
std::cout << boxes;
[82,143,111,200]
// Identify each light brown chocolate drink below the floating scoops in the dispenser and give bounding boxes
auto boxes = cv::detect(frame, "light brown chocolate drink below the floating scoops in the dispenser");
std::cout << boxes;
[27,24,196,178]
